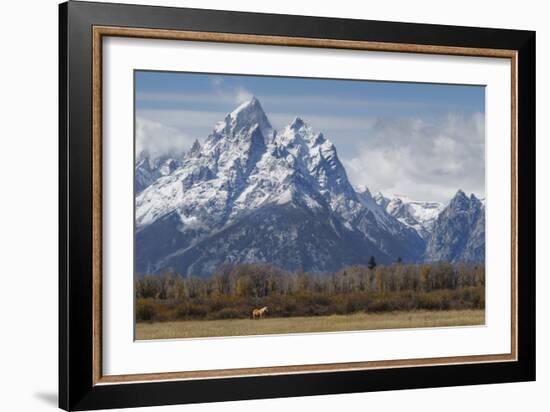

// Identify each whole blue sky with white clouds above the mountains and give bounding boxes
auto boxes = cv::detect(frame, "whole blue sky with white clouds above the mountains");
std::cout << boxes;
[135,71,485,201]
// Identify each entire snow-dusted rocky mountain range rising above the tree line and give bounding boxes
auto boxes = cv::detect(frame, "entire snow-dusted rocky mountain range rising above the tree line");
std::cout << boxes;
[135,98,485,275]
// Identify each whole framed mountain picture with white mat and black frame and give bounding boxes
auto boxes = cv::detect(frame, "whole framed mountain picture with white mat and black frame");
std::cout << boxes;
[59,1,535,410]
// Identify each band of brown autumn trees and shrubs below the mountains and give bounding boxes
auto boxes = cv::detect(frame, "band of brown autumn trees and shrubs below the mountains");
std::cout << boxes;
[135,258,485,321]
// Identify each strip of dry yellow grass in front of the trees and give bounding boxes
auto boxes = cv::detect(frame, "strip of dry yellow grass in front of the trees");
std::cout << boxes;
[136,309,485,340]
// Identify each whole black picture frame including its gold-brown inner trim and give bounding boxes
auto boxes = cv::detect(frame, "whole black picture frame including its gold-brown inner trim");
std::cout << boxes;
[59,1,535,410]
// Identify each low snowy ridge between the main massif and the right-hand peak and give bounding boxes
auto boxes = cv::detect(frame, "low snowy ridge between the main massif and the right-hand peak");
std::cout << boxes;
[374,192,445,240]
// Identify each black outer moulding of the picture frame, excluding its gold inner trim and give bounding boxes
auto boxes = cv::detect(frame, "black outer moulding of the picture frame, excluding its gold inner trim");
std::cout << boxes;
[59,1,536,410]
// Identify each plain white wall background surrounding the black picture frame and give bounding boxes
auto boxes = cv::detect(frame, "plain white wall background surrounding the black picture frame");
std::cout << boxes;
[0,0,550,412]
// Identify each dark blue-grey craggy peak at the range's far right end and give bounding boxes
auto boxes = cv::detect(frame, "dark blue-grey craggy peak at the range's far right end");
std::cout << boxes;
[425,190,485,262]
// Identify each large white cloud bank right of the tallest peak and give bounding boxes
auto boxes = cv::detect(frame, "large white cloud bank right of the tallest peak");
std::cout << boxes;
[343,114,485,201]
